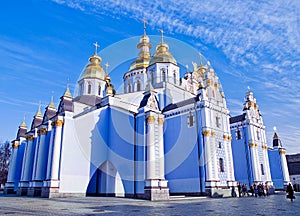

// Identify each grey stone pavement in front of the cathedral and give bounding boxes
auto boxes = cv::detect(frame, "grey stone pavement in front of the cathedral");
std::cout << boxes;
[0,192,300,216]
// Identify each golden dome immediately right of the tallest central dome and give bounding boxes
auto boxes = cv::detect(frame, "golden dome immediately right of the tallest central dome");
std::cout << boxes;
[149,42,177,65]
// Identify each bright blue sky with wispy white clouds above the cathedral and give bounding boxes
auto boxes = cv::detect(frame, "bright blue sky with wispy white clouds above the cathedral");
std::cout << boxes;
[0,0,300,154]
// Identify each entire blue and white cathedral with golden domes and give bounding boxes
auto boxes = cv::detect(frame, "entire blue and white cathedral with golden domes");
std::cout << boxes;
[5,26,289,200]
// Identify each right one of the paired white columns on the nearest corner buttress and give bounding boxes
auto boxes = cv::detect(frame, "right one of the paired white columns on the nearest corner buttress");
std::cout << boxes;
[158,117,165,179]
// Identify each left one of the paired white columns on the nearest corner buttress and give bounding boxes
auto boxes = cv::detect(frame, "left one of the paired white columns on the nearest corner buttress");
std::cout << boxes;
[146,116,155,179]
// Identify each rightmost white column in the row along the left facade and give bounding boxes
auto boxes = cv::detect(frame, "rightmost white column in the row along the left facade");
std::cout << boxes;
[50,119,63,180]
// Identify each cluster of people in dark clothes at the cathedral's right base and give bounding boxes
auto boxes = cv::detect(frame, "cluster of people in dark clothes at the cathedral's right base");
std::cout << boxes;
[237,182,270,197]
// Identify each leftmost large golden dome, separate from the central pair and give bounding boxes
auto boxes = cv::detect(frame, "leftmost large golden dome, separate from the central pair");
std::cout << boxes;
[79,54,106,81]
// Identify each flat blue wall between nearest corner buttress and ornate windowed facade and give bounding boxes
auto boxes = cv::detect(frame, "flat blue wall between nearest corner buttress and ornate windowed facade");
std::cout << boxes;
[164,112,200,193]
